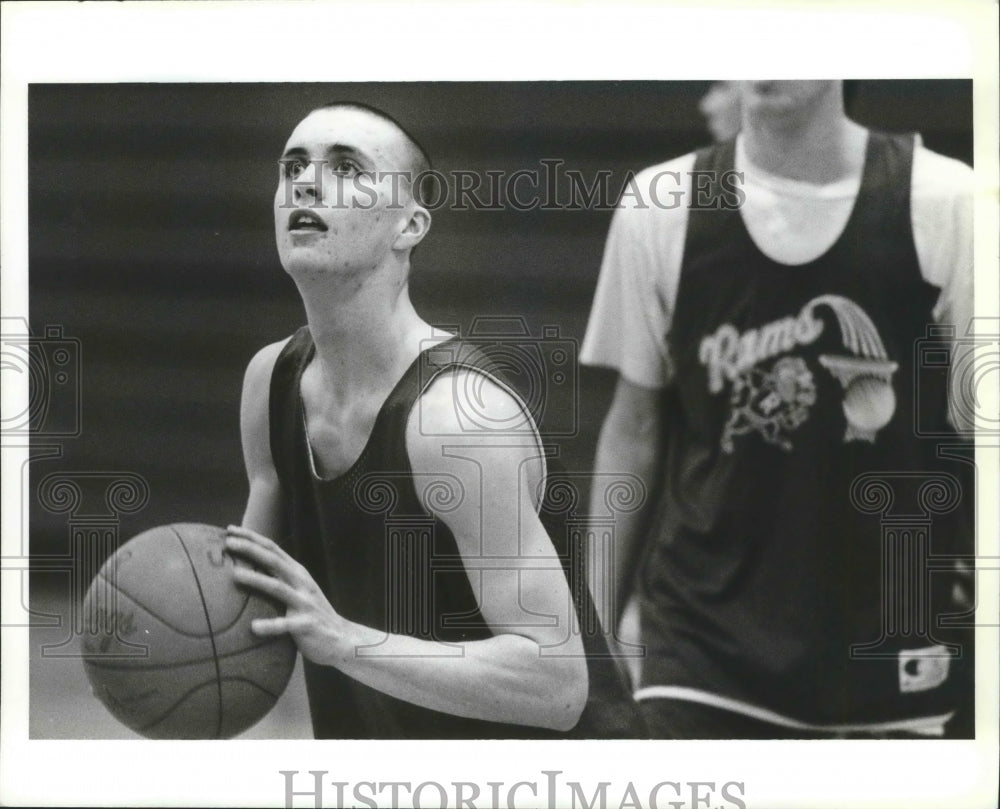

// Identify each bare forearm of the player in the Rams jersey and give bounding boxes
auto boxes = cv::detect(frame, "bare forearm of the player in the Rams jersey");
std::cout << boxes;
[590,400,659,631]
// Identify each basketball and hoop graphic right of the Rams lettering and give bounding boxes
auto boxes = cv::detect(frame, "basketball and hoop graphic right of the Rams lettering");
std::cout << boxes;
[811,295,899,442]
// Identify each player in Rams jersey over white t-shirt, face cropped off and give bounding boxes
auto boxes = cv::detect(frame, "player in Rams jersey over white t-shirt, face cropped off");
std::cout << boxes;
[581,81,972,738]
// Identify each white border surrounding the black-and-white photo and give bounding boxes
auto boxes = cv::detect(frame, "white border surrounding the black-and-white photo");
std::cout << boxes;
[0,0,1000,809]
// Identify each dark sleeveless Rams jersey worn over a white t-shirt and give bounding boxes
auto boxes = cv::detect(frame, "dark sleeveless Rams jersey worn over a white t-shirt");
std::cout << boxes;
[639,133,968,727]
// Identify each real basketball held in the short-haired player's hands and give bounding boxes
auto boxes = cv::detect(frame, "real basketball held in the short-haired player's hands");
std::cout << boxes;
[82,523,296,739]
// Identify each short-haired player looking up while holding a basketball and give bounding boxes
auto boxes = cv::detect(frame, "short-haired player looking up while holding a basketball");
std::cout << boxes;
[228,104,637,738]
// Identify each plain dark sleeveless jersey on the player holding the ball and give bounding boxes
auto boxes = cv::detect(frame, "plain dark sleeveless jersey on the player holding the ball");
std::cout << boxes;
[270,327,639,739]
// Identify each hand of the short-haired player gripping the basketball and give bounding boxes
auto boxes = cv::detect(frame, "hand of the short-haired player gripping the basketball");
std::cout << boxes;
[226,525,348,665]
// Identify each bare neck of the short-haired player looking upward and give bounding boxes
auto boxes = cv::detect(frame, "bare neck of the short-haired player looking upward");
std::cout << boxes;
[297,266,431,400]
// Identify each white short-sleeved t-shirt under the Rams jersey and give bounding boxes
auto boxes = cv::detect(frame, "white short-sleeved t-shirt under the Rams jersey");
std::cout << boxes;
[580,133,973,388]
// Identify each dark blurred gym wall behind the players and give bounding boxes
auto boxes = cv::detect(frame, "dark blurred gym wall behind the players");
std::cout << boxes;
[29,81,972,554]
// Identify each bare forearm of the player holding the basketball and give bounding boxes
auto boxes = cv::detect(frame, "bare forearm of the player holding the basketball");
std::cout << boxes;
[317,622,588,731]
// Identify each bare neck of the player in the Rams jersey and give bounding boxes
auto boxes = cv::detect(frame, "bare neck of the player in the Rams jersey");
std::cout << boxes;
[741,108,868,184]
